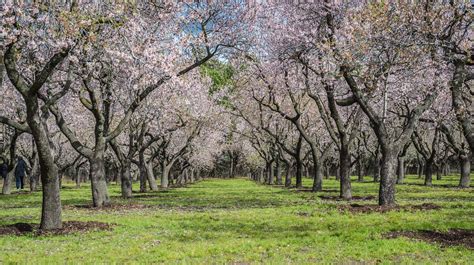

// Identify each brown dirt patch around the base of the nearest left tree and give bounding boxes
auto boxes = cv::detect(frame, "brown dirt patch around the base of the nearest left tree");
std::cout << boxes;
[0,221,113,236]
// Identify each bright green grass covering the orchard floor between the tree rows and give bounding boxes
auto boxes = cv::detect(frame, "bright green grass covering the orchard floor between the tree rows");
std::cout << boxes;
[0,174,474,264]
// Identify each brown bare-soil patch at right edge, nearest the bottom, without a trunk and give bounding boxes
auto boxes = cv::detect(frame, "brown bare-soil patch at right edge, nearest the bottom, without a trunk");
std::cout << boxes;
[384,229,474,250]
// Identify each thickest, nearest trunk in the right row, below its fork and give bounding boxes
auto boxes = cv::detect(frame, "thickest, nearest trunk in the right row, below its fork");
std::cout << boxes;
[379,147,398,206]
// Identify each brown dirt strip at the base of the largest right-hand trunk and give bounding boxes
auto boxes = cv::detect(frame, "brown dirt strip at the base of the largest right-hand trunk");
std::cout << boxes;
[339,203,441,213]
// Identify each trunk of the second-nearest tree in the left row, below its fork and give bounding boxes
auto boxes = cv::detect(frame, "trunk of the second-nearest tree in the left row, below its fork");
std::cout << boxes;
[89,156,110,207]
